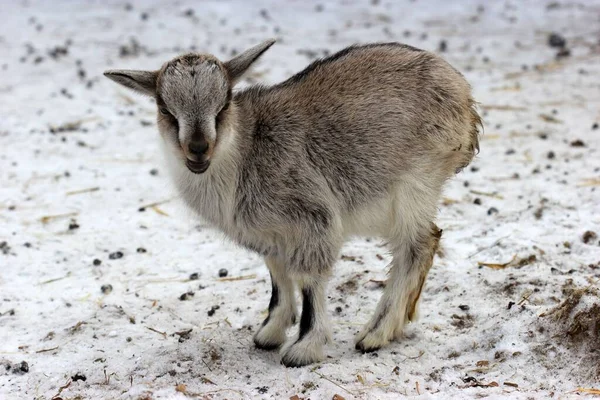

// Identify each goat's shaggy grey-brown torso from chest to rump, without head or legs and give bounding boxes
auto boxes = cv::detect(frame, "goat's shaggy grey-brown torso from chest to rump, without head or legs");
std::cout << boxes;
[166,44,478,272]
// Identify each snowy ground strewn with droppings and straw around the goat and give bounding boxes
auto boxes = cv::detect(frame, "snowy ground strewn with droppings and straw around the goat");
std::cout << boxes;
[0,0,600,399]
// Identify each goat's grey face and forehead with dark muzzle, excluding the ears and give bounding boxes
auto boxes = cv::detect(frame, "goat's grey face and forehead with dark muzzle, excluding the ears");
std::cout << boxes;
[155,54,231,174]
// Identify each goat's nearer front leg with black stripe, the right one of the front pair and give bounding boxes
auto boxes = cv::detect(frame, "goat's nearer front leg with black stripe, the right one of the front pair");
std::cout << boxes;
[281,275,331,367]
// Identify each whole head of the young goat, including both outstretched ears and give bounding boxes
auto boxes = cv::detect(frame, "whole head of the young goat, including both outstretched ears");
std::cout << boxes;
[104,40,274,174]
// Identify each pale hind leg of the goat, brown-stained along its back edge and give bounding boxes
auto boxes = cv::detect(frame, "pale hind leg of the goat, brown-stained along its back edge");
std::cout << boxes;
[356,223,442,352]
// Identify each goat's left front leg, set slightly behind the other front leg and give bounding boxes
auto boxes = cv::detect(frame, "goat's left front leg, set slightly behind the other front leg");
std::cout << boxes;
[254,257,296,350]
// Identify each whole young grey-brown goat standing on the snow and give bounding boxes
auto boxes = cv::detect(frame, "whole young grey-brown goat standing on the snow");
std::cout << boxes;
[105,41,481,366]
